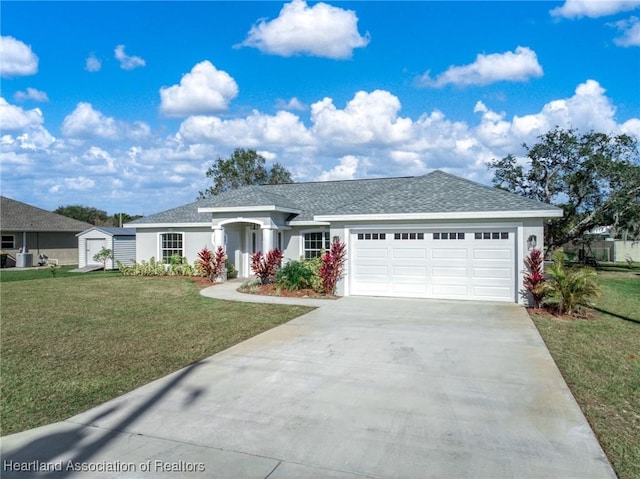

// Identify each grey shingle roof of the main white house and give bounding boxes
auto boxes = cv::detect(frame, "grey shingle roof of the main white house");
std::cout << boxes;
[131,171,558,224]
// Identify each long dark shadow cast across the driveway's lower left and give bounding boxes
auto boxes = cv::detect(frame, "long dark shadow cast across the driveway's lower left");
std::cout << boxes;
[0,362,204,479]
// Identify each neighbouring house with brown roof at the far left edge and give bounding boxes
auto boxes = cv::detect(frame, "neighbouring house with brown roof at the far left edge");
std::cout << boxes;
[0,196,92,267]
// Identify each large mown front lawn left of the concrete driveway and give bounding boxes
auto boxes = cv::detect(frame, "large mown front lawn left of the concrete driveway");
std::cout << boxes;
[0,271,311,435]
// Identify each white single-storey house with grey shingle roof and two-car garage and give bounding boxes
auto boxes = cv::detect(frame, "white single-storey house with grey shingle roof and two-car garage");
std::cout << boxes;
[129,171,562,302]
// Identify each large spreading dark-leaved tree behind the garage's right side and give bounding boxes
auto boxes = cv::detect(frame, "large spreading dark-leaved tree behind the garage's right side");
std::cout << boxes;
[488,127,640,249]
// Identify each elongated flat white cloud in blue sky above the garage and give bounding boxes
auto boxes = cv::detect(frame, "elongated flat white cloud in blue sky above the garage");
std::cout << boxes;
[416,46,543,88]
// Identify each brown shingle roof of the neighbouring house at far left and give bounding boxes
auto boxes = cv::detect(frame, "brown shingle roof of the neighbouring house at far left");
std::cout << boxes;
[0,196,93,233]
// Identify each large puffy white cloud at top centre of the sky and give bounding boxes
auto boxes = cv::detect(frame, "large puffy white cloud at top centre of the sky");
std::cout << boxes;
[240,0,369,59]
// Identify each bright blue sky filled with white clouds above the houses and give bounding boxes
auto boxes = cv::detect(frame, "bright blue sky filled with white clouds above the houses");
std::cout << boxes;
[0,0,640,214]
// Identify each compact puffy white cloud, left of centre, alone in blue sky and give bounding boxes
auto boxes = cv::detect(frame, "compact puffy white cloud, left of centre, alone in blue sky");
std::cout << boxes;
[160,60,238,117]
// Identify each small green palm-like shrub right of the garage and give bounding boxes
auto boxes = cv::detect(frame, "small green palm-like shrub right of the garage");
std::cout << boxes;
[540,250,600,314]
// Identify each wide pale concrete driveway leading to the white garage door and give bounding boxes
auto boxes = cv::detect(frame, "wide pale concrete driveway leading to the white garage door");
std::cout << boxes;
[2,297,615,479]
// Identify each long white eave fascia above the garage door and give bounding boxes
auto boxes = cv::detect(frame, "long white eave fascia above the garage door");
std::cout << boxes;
[313,209,563,222]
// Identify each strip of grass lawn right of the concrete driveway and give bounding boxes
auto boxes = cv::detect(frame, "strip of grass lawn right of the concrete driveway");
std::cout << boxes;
[532,271,640,479]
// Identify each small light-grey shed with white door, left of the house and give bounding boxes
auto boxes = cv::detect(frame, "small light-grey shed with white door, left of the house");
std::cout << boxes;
[76,226,136,269]
